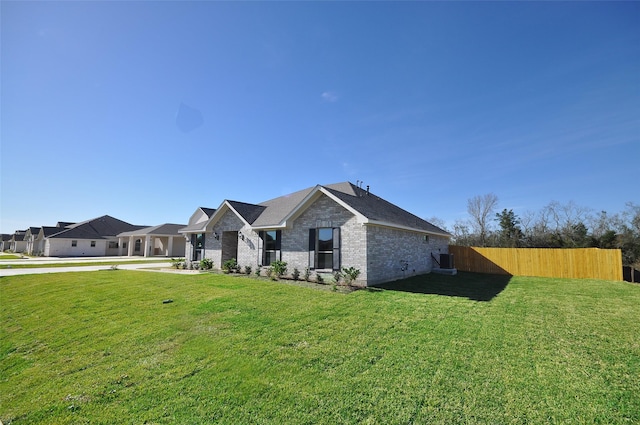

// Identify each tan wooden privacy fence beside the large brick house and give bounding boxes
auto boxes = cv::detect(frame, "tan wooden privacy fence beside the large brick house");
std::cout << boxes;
[449,245,622,280]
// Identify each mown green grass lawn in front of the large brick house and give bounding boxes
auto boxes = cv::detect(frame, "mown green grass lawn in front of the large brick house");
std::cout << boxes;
[0,270,640,425]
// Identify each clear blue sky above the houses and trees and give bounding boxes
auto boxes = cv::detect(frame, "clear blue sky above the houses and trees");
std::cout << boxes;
[0,2,640,233]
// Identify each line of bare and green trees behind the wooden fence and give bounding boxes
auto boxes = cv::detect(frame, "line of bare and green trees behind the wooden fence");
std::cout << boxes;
[433,193,640,268]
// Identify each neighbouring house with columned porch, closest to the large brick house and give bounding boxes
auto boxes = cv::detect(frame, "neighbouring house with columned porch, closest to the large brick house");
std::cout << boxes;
[118,223,185,257]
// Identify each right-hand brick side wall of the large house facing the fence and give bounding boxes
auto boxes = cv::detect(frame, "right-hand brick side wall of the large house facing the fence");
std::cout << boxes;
[367,225,449,285]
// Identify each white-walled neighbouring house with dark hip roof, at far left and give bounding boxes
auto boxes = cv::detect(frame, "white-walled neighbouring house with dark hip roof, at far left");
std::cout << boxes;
[43,215,147,257]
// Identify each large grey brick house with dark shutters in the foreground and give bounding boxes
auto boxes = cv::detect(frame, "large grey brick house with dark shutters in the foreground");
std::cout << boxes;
[180,182,451,285]
